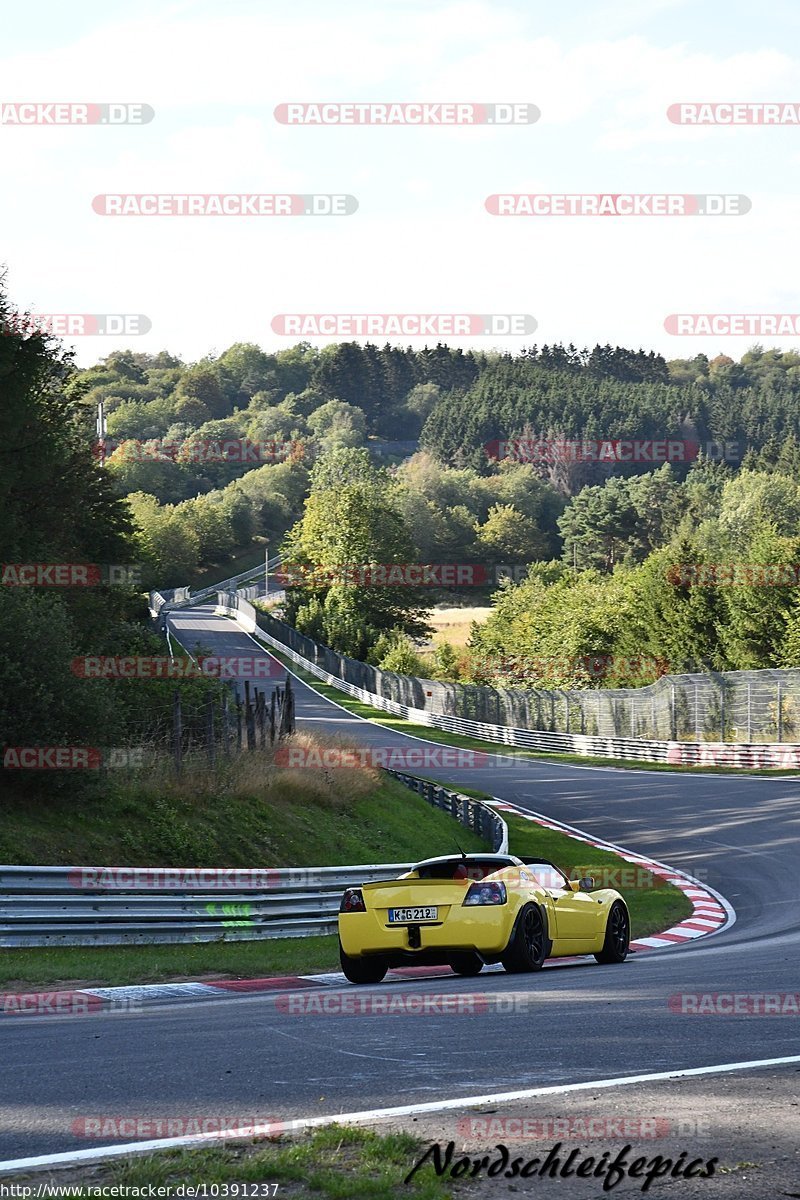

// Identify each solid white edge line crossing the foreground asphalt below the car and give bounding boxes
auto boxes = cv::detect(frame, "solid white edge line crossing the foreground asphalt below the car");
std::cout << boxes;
[0,1055,800,1175]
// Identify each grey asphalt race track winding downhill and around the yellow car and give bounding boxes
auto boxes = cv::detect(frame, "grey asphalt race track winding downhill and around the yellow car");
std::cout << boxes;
[0,608,800,1198]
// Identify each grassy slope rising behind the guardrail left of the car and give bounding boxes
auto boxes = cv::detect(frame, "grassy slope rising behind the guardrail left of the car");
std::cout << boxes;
[0,772,485,866]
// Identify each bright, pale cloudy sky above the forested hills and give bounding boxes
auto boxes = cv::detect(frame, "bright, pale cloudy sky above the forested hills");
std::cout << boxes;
[0,0,800,366]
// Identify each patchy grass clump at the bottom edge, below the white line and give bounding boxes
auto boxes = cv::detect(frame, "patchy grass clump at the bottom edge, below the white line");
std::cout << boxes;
[14,1126,468,1200]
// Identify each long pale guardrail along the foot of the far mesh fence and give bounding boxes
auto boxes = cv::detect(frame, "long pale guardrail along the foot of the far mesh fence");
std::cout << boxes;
[244,606,800,770]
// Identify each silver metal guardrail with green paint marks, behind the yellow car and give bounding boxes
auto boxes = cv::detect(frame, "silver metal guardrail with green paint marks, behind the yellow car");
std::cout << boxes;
[0,772,509,947]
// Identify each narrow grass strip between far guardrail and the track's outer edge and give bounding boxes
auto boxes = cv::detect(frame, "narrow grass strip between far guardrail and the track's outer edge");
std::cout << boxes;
[267,646,800,778]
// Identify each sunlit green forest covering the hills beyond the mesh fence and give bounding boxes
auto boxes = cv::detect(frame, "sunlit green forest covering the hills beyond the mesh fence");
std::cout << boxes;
[5,278,800,686]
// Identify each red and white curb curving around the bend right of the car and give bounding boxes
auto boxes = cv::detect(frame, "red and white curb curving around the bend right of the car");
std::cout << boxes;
[487,798,736,952]
